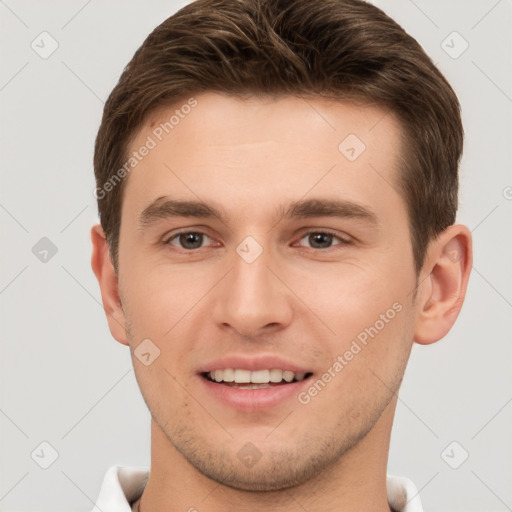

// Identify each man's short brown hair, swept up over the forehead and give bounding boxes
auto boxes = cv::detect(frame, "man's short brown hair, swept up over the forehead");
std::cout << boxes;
[94,0,463,273]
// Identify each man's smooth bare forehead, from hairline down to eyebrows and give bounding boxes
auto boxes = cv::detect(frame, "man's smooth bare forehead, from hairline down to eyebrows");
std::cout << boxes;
[124,93,401,221]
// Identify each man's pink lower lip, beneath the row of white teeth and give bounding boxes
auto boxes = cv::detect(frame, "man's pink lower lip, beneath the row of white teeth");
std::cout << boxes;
[199,376,311,412]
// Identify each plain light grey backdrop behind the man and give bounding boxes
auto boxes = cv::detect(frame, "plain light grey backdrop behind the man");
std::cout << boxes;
[0,0,512,512]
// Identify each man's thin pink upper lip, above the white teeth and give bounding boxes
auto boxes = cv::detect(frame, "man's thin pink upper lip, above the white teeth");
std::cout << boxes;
[198,354,311,373]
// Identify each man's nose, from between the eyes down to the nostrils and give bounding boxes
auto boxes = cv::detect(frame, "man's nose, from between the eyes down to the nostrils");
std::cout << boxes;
[213,242,293,337]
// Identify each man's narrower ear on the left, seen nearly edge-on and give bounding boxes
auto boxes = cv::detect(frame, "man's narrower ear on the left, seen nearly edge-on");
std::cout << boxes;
[91,224,128,345]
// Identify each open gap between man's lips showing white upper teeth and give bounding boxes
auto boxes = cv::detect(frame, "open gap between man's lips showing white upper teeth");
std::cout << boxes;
[201,368,313,389]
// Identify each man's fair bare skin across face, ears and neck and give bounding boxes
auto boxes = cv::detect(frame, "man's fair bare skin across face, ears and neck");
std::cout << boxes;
[91,93,472,512]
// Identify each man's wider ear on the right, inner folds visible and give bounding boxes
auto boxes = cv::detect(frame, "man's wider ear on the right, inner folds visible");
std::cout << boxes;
[414,224,473,345]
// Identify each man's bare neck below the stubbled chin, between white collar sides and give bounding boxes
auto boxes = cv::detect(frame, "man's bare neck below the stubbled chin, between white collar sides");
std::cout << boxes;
[134,397,397,512]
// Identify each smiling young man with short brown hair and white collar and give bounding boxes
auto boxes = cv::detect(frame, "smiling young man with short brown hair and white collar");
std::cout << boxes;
[91,0,472,512]
